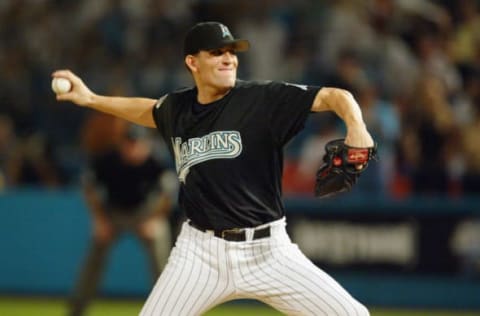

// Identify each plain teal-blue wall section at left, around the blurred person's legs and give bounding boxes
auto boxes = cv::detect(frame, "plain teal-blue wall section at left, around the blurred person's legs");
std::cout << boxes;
[0,190,151,295]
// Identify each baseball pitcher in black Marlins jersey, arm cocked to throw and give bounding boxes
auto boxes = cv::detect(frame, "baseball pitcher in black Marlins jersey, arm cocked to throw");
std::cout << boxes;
[53,22,375,316]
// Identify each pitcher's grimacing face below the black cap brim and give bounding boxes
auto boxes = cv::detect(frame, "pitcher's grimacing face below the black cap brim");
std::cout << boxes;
[189,47,238,89]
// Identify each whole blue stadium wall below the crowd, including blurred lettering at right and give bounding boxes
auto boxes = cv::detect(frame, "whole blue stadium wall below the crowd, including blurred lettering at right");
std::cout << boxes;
[0,189,480,309]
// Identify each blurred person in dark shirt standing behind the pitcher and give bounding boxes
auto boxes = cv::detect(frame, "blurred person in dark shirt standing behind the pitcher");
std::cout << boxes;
[70,114,176,316]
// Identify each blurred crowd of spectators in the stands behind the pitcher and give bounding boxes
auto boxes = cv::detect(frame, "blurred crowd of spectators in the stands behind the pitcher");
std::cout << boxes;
[0,0,480,197]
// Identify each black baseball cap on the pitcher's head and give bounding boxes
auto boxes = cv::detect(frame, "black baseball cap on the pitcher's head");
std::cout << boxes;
[183,22,250,56]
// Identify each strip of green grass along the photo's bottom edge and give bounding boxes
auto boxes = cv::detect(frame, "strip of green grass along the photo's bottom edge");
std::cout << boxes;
[0,297,480,316]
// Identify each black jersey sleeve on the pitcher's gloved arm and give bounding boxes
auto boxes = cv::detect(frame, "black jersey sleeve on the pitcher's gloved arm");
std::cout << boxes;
[267,82,320,145]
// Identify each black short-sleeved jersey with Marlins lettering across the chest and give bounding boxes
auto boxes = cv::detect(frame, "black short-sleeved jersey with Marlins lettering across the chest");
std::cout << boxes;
[153,81,319,229]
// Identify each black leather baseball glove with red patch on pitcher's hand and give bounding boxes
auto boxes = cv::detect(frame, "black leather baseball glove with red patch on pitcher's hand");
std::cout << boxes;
[315,139,377,198]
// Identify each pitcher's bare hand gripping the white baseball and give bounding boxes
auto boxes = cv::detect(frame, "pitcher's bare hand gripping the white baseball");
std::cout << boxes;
[52,70,94,106]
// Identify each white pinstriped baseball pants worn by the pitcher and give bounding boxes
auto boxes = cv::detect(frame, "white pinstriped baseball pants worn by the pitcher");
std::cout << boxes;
[140,219,369,316]
